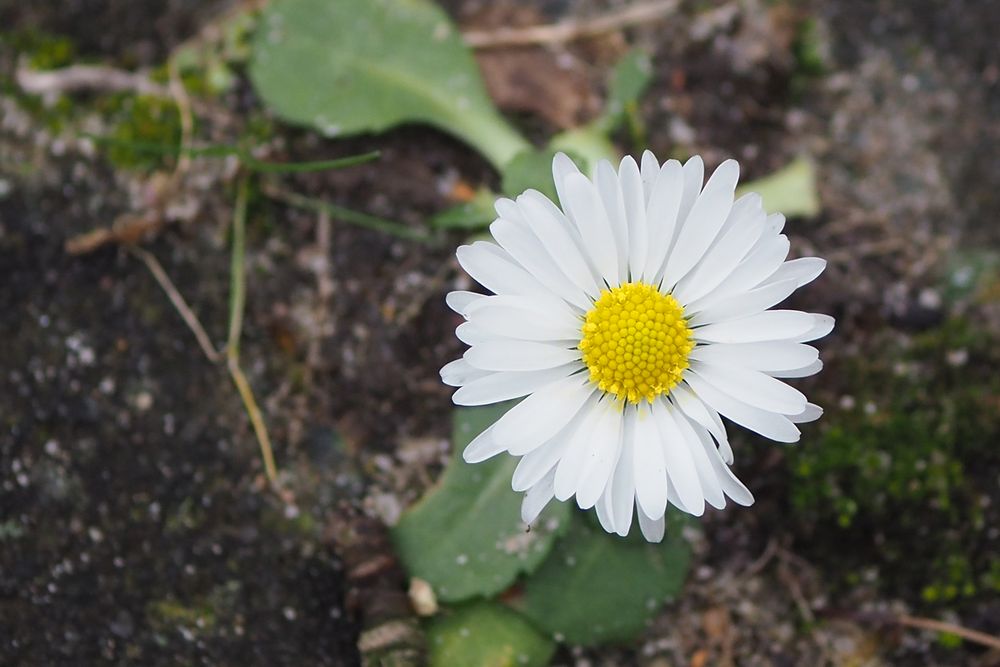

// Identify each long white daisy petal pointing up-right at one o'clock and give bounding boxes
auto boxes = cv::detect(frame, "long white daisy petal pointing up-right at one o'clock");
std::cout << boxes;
[663,160,740,287]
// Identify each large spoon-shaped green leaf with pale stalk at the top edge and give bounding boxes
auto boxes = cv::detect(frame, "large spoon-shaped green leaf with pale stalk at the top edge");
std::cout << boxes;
[249,0,528,169]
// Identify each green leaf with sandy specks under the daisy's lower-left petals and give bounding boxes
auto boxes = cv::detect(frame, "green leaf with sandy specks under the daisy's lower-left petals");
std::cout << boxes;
[392,403,569,602]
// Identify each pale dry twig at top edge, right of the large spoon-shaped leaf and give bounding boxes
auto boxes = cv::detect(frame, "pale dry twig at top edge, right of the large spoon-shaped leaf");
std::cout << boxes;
[462,0,680,49]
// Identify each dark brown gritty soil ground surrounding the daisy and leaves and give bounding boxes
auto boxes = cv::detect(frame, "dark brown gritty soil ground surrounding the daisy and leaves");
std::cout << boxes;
[0,0,1000,666]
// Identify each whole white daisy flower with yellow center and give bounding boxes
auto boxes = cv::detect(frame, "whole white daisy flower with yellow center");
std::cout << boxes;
[441,151,833,542]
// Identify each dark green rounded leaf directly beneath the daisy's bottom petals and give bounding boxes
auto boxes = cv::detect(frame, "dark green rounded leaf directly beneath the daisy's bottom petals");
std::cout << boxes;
[513,513,690,646]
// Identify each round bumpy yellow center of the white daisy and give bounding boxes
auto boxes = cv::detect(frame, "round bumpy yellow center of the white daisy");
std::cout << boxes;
[579,282,694,403]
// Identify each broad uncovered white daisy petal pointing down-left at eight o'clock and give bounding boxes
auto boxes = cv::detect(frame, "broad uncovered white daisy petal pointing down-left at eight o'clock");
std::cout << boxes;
[493,375,594,456]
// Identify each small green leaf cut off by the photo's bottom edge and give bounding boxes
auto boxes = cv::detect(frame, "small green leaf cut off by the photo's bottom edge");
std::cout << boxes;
[427,602,555,667]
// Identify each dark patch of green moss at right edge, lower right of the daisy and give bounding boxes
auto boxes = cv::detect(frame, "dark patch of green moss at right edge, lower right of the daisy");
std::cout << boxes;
[786,320,1000,605]
